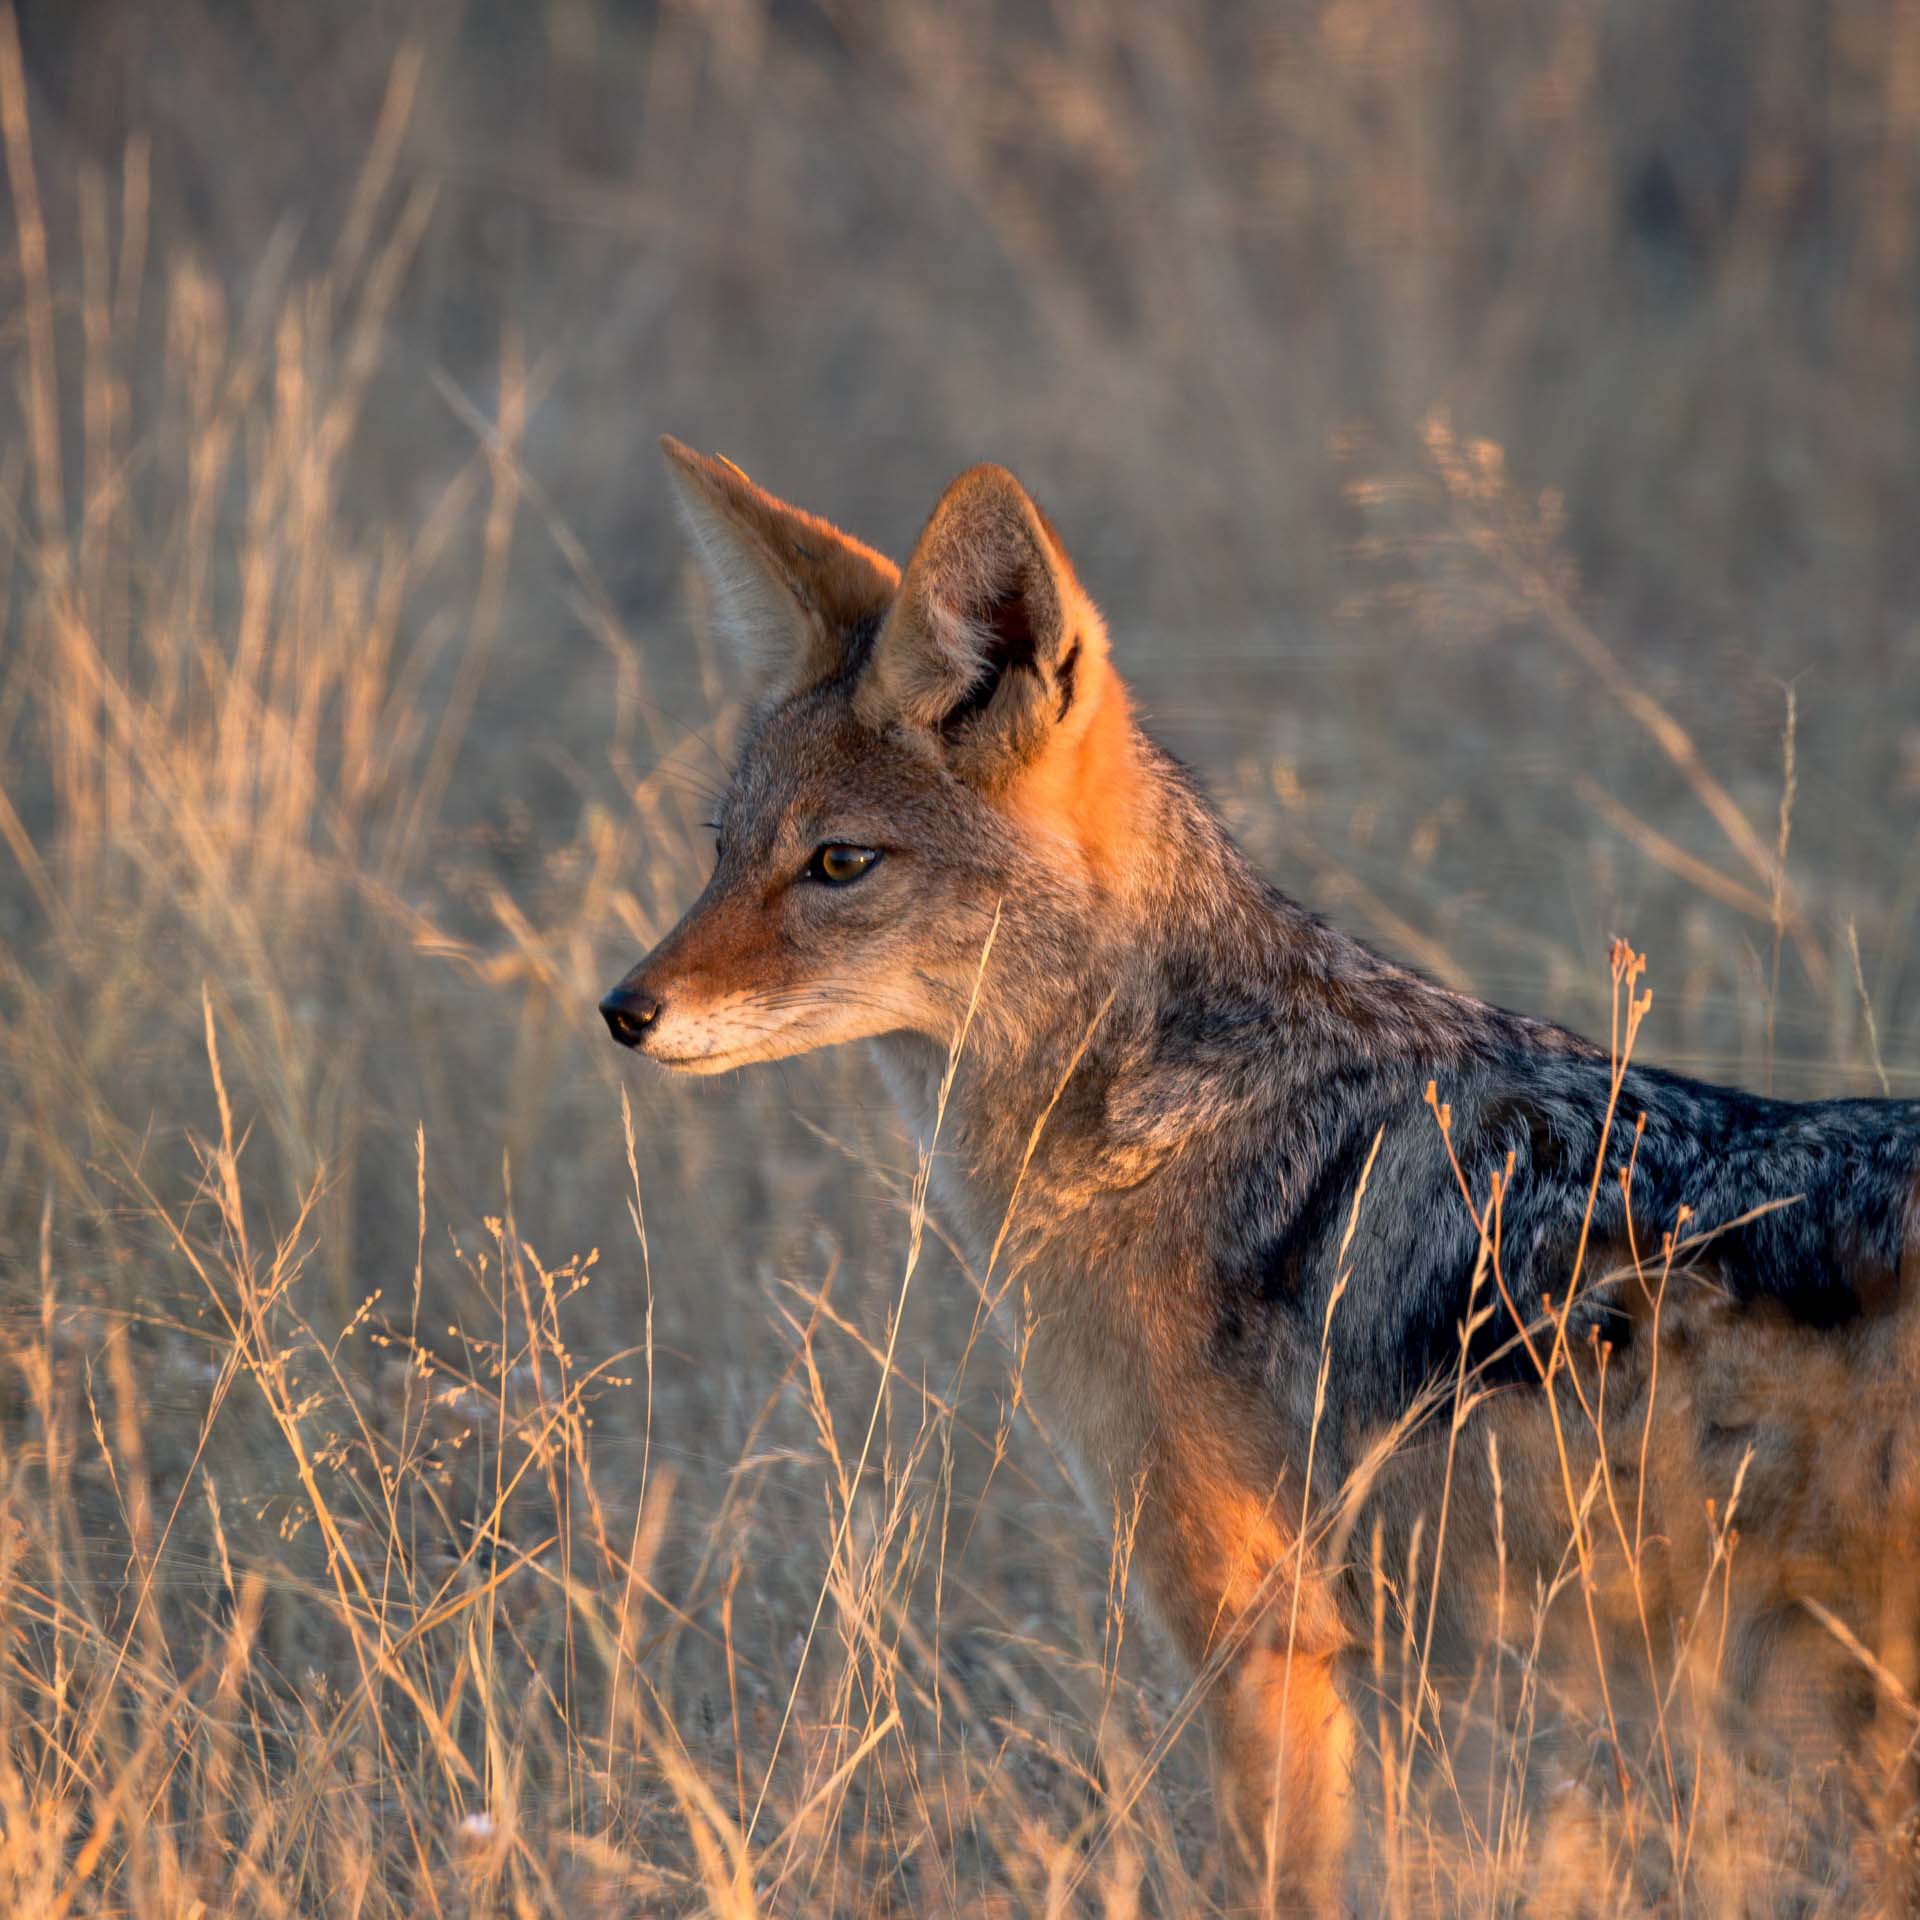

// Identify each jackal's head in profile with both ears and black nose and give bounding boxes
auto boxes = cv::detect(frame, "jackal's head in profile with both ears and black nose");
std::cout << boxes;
[601,440,1135,1073]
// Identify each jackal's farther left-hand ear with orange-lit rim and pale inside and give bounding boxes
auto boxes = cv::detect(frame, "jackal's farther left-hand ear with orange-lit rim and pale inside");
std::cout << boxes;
[660,434,900,699]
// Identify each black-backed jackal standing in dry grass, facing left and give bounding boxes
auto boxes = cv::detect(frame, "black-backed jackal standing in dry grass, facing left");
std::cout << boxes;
[603,440,1920,1910]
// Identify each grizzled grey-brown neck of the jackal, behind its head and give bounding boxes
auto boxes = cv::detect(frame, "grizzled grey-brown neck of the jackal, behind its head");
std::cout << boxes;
[881,728,1536,1213]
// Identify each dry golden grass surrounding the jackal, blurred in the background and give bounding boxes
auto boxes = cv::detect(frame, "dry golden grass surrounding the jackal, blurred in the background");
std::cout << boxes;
[0,0,1920,1916]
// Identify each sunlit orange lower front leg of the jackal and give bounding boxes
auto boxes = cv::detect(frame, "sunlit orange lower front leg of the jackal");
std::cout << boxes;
[1213,1628,1354,1920]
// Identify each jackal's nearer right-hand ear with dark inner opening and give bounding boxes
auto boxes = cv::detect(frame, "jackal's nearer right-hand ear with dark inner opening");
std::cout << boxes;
[854,467,1112,785]
